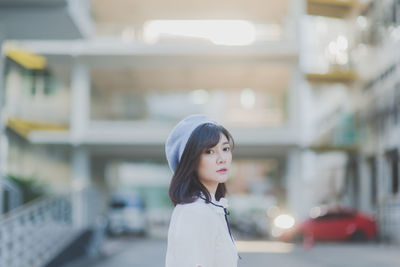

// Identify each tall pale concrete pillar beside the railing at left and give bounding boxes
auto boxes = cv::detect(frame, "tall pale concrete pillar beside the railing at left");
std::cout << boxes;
[70,59,91,229]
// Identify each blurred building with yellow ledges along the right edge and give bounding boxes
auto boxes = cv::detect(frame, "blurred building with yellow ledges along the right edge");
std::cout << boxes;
[296,1,400,242]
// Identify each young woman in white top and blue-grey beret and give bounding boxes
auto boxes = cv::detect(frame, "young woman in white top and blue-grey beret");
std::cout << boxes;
[165,115,238,267]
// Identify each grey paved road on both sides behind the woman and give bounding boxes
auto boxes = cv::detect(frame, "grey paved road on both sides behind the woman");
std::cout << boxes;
[68,237,400,267]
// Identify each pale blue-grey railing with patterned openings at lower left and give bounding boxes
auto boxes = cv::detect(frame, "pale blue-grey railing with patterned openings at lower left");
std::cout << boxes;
[0,196,76,267]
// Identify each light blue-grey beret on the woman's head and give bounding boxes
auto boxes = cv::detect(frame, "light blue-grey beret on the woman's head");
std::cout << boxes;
[165,114,218,172]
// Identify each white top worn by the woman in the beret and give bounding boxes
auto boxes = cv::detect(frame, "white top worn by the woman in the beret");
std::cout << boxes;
[165,195,238,267]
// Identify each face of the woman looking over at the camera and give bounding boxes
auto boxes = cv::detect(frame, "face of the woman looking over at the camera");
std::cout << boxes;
[197,133,232,194]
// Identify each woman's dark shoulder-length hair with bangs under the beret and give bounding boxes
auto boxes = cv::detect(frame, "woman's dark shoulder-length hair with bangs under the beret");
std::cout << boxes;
[169,123,234,206]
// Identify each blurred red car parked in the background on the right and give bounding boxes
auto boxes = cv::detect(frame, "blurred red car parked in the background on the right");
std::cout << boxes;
[279,207,377,242]
